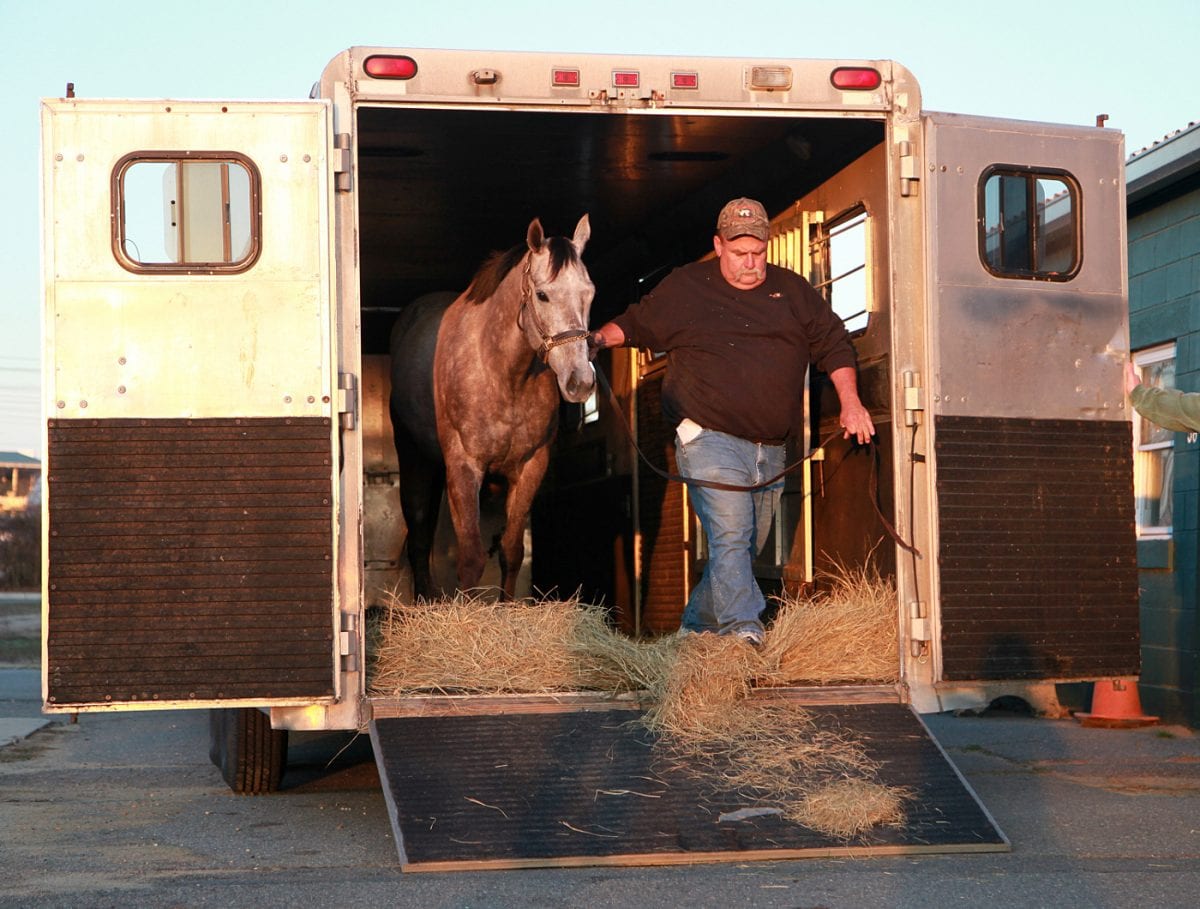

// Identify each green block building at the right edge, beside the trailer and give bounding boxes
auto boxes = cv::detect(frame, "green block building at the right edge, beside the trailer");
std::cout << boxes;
[1126,124,1200,727]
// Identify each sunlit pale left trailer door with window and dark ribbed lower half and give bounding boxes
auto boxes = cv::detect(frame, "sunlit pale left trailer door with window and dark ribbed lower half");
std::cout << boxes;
[42,100,337,711]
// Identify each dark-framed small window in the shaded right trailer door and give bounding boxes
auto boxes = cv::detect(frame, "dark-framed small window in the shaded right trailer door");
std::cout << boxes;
[979,167,1081,281]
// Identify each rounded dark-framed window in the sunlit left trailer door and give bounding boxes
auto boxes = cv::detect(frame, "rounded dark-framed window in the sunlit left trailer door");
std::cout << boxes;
[113,152,262,273]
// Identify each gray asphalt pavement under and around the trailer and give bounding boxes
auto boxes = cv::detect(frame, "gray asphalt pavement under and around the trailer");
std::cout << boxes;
[0,594,1200,909]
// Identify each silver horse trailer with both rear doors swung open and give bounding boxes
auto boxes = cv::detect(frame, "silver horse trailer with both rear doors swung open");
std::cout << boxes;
[41,48,1140,868]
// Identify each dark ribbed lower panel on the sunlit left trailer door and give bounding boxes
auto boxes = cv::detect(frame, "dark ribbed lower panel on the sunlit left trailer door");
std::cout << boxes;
[47,417,334,706]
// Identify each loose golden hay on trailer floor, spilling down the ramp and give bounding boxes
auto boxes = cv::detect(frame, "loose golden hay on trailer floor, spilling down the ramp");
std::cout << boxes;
[371,570,912,839]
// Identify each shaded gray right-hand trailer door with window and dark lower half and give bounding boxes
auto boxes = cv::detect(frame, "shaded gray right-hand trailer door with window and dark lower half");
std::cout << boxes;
[925,115,1139,680]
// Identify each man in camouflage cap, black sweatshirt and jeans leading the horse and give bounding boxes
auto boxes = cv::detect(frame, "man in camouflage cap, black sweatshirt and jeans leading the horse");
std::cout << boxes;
[589,199,875,645]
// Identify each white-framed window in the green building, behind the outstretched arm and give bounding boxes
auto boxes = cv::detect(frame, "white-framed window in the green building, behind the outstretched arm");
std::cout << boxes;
[1133,344,1175,540]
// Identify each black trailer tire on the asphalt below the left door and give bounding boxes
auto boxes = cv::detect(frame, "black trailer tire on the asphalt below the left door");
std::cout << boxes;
[209,708,288,795]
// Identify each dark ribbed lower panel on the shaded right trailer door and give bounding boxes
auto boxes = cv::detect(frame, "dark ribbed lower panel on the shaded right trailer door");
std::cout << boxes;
[936,416,1139,680]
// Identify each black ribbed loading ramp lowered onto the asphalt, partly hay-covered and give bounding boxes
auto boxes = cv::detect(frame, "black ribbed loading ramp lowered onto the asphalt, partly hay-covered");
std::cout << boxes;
[371,703,1009,871]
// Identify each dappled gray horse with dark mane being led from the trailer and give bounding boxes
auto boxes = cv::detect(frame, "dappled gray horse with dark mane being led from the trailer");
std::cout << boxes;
[390,215,595,598]
